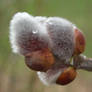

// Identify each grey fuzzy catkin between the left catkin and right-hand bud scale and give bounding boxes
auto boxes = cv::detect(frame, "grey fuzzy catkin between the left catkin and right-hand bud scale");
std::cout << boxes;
[46,17,74,62]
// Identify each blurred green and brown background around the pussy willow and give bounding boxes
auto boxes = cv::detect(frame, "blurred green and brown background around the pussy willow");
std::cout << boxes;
[0,0,92,92]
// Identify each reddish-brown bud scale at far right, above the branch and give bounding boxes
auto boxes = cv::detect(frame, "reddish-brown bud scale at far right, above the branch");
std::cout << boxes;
[74,28,85,55]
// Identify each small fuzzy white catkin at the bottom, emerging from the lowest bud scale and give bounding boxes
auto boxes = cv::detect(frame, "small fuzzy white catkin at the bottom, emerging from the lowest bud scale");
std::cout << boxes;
[37,62,66,85]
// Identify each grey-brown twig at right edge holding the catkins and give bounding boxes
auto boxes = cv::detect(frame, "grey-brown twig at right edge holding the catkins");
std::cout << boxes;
[74,55,92,71]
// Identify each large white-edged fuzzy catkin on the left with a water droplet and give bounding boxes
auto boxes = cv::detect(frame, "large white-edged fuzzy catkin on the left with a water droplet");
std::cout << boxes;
[10,12,49,55]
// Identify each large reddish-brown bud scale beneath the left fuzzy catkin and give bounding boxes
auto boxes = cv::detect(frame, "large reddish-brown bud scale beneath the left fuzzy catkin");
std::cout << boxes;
[25,49,54,72]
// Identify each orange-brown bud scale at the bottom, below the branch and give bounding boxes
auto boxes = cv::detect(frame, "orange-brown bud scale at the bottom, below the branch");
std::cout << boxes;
[56,67,77,85]
